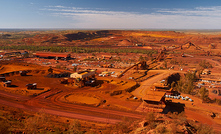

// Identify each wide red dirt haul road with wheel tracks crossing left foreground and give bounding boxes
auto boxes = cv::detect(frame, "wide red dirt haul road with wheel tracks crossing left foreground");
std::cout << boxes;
[0,90,142,124]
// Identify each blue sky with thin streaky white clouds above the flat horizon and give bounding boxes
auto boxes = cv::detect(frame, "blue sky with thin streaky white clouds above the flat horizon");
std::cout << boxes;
[0,0,221,29]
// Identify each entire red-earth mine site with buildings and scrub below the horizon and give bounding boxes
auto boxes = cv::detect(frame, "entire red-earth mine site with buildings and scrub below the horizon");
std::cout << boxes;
[0,30,221,134]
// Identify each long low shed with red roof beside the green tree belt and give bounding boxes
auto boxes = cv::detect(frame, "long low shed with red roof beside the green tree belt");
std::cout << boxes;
[33,52,71,60]
